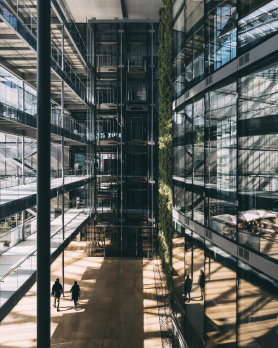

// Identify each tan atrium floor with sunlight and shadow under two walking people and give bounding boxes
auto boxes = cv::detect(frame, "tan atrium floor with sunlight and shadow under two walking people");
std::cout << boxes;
[0,242,162,348]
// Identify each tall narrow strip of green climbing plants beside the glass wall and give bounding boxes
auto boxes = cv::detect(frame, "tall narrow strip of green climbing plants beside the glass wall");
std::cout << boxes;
[158,0,173,293]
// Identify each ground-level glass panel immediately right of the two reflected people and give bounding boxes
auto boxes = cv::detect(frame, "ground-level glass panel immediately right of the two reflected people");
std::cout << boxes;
[205,241,237,348]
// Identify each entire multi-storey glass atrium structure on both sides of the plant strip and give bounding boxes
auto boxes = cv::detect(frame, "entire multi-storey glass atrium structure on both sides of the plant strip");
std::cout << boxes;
[0,0,278,348]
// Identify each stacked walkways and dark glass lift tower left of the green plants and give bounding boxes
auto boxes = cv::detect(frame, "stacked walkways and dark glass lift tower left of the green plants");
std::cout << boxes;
[0,0,160,324]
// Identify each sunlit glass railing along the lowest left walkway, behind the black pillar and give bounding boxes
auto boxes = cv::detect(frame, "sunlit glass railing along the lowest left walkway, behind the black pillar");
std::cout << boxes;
[0,209,88,307]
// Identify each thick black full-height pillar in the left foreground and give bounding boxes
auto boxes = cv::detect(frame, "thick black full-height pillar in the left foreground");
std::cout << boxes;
[37,0,51,348]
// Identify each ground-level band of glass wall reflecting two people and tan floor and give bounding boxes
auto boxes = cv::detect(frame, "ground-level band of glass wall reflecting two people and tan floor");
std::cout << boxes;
[172,223,278,348]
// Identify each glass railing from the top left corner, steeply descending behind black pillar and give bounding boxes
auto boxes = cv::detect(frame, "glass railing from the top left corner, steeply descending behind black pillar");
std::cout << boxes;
[0,0,91,100]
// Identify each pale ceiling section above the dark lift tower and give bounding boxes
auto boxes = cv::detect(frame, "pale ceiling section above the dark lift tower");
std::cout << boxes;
[64,0,161,23]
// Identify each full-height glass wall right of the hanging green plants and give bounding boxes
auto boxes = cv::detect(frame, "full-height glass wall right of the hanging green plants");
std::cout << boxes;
[172,0,278,348]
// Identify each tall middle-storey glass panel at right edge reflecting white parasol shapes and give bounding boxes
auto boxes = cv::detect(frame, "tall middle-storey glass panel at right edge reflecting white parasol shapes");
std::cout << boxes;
[238,61,278,259]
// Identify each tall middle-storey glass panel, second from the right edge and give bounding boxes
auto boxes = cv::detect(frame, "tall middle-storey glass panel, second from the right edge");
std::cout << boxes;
[206,83,237,239]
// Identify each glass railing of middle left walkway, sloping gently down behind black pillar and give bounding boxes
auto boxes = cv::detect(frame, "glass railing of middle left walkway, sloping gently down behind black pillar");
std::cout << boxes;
[0,103,88,142]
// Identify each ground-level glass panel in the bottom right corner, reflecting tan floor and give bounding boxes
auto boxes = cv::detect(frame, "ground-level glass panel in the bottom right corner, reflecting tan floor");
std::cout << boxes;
[237,261,278,348]
